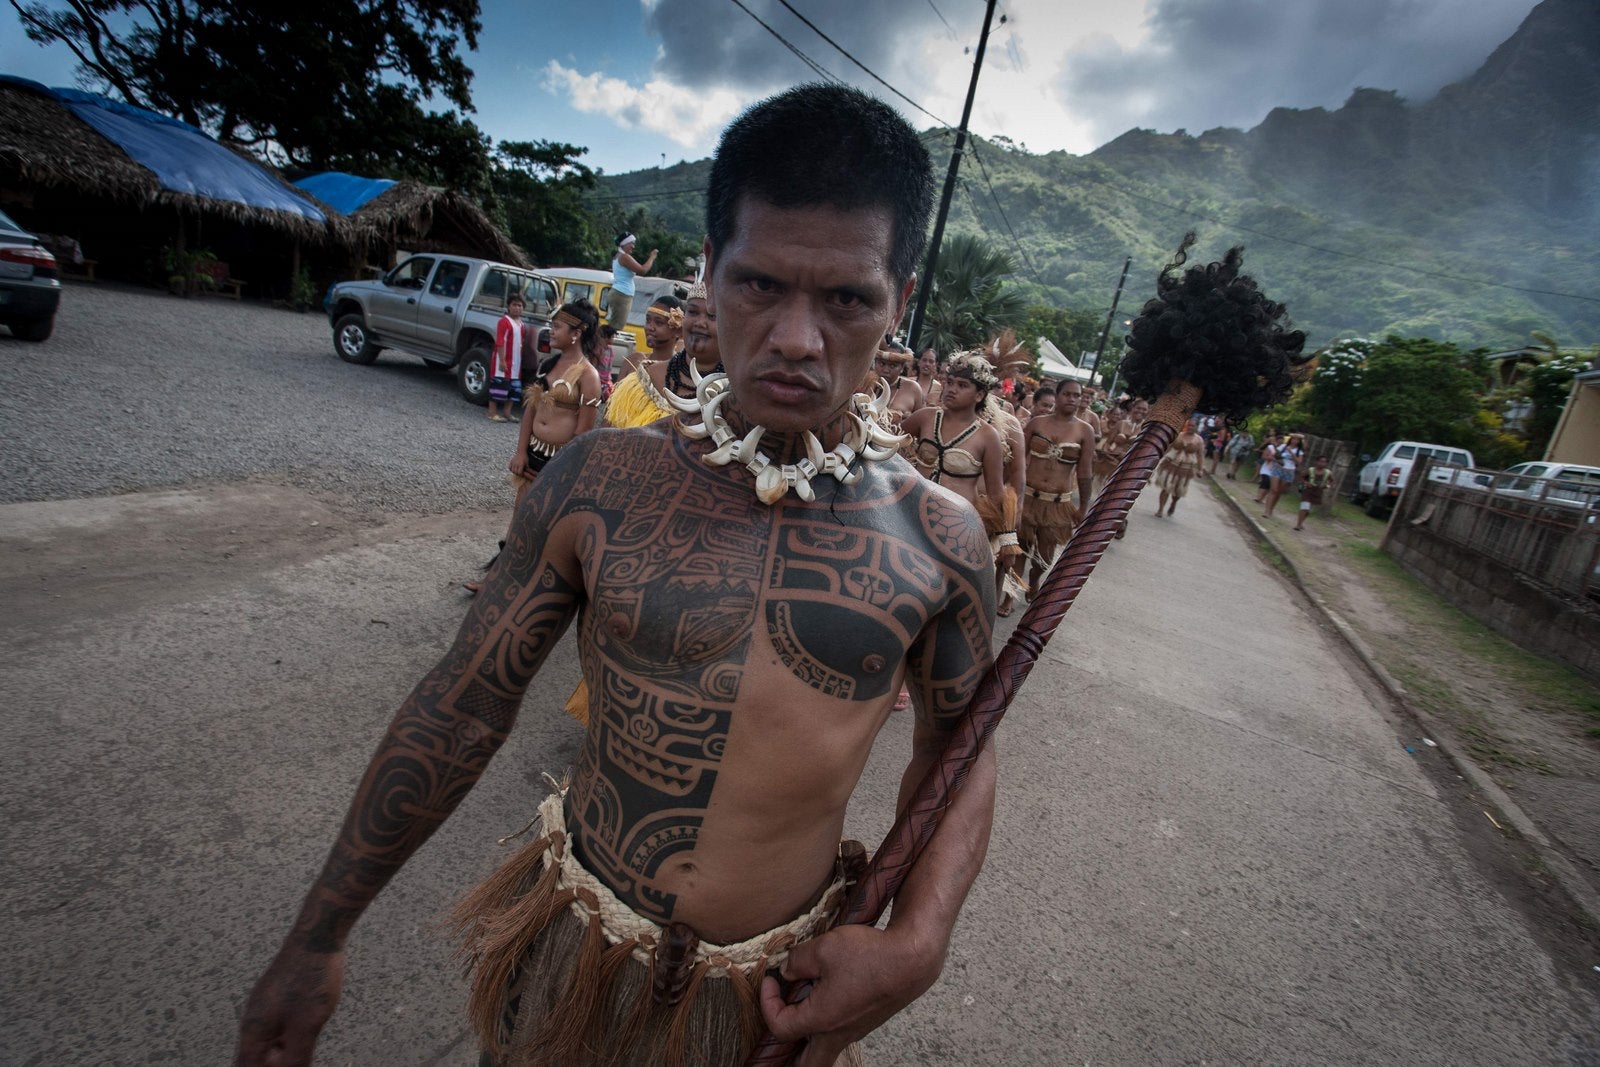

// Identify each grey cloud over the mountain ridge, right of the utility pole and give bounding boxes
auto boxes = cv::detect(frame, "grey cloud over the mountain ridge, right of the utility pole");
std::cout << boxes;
[1058,0,1533,141]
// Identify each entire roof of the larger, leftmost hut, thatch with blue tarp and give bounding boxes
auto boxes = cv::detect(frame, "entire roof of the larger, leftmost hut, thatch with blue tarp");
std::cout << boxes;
[0,75,344,245]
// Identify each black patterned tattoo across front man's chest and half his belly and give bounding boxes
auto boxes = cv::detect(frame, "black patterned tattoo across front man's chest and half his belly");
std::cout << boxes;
[568,438,960,921]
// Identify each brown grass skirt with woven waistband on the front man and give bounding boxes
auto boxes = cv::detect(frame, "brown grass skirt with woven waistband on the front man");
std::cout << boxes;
[453,795,866,1067]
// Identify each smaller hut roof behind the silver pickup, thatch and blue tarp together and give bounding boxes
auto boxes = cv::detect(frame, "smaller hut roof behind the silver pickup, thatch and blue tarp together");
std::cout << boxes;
[294,171,533,267]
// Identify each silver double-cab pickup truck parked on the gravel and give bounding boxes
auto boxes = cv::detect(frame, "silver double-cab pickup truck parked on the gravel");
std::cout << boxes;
[325,253,555,405]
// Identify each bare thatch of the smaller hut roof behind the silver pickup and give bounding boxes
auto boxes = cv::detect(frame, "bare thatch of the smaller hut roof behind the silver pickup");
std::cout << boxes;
[346,181,533,267]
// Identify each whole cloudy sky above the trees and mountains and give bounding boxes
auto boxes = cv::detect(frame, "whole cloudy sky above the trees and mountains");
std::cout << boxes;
[0,0,1534,173]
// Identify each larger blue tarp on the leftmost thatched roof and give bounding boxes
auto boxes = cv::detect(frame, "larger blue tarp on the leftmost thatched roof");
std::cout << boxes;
[6,78,326,222]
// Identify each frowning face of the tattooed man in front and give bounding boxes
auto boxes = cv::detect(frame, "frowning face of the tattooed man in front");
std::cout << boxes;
[706,198,912,432]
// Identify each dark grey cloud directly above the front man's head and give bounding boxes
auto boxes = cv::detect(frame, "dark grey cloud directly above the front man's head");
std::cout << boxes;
[646,0,946,93]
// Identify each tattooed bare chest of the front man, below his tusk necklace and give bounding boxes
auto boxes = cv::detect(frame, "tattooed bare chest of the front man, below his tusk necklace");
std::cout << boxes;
[582,486,949,701]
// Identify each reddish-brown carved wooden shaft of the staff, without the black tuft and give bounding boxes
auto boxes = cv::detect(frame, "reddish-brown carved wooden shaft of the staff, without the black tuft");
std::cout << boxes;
[746,381,1200,1067]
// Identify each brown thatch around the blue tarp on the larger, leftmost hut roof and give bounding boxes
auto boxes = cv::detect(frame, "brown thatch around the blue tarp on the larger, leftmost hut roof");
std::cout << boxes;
[0,77,337,243]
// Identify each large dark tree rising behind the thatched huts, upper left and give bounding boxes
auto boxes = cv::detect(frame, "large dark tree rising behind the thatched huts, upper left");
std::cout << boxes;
[13,0,490,194]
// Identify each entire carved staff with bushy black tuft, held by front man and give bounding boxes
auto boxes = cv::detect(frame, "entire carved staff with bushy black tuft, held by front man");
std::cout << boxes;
[746,234,1306,1067]
